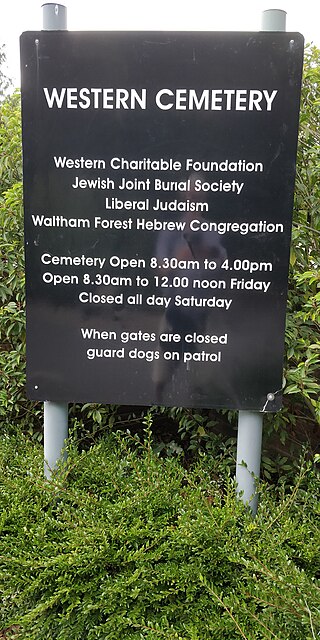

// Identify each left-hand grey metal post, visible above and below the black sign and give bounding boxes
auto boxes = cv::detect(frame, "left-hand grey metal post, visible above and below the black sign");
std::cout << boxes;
[42,3,68,479]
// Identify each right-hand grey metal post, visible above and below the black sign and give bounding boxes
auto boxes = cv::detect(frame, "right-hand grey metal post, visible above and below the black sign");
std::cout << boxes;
[236,9,286,515]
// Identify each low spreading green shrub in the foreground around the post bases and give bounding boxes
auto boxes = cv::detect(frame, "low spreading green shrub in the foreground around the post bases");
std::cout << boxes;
[0,430,320,640]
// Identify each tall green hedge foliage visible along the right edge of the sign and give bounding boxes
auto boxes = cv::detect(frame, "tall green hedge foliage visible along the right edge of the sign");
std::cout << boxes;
[285,47,320,424]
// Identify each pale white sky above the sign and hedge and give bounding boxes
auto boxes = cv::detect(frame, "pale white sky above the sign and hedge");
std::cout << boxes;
[0,0,320,87]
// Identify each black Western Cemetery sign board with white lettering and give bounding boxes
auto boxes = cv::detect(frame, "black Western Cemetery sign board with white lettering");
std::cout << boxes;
[21,31,303,411]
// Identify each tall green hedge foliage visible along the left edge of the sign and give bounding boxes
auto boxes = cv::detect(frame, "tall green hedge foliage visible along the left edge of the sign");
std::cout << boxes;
[0,92,41,432]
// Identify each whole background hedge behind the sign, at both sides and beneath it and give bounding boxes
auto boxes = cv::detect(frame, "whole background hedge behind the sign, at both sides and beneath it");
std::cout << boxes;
[0,47,320,464]
